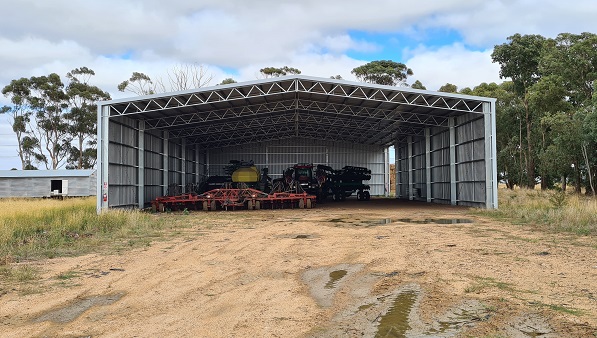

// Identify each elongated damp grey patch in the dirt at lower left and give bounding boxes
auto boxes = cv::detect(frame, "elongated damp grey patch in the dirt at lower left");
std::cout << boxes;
[33,293,124,323]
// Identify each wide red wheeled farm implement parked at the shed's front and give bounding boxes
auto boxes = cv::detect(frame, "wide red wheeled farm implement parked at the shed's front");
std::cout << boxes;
[151,188,316,212]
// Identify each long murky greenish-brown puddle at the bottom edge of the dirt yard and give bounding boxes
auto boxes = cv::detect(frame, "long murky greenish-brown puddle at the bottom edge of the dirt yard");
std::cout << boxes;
[375,291,417,337]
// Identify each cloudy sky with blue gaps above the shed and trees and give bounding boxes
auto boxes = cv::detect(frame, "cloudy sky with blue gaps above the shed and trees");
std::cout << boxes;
[0,0,597,170]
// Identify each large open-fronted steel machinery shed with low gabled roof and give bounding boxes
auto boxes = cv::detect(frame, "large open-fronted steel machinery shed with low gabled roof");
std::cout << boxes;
[97,75,497,212]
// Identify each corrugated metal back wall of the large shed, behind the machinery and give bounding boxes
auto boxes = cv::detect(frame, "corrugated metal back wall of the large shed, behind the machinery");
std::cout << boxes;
[206,138,389,196]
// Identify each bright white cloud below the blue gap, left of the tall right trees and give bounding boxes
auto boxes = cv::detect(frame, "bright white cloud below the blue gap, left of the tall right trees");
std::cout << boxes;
[406,43,503,90]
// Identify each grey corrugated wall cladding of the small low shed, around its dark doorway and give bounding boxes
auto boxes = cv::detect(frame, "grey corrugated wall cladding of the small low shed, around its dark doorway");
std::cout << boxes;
[0,170,97,198]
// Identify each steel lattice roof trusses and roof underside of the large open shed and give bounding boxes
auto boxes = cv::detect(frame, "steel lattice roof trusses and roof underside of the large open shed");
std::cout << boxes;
[106,76,484,147]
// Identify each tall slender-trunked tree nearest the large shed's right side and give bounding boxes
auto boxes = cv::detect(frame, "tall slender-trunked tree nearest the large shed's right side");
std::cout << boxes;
[491,34,545,188]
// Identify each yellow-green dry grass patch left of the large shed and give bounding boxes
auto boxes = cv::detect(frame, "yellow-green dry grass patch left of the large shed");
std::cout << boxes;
[0,197,159,265]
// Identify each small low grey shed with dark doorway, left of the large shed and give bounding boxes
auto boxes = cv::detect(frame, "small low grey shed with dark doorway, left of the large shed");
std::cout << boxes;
[0,170,97,198]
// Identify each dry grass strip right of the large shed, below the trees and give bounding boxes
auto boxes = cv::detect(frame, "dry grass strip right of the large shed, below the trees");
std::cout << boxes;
[484,189,597,235]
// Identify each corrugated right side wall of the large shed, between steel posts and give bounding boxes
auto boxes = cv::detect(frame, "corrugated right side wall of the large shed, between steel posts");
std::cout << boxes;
[395,114,486,207]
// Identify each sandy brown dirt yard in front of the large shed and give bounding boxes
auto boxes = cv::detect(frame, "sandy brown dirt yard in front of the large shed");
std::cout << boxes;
[0,199,597,337]
